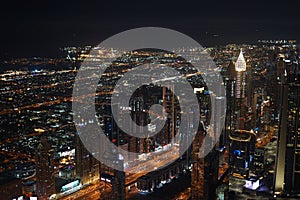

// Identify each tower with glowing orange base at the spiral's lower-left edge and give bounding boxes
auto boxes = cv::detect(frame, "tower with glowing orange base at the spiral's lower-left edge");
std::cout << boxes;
[75,135,100,185]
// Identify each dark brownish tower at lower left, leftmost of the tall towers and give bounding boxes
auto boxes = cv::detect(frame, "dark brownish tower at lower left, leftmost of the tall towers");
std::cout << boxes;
[36,137,55,199]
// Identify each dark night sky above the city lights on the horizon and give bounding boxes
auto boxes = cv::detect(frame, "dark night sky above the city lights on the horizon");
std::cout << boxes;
[0,0,300,57]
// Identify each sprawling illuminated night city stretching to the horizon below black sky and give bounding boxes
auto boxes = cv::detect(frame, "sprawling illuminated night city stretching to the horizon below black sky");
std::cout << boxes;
[0,40,299,199]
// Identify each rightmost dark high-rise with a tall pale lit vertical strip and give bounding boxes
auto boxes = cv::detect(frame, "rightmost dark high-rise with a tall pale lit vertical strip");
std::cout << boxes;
[273,75,300,196]
